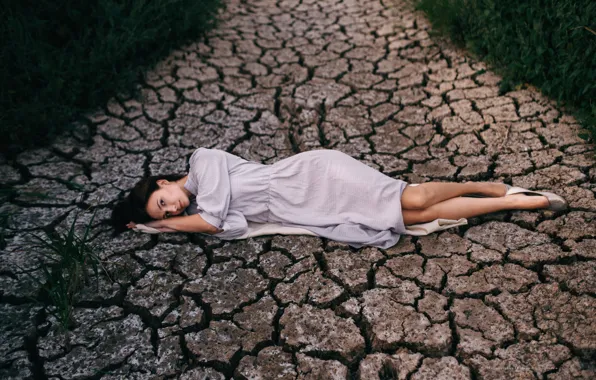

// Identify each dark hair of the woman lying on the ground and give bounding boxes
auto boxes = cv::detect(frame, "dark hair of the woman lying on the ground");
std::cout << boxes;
[110,174,186,234]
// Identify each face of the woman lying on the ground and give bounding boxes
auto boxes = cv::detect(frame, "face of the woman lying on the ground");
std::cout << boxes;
[147,179,190,219]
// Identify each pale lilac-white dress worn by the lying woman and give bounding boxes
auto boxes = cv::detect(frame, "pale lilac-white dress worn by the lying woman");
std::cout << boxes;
[185,148,407,248]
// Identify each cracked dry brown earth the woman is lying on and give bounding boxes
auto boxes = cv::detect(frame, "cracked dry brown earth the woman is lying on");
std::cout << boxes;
[0,0,596,380]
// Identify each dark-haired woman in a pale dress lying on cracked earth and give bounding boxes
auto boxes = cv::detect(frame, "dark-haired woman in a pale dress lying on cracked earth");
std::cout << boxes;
[112,148,566,248]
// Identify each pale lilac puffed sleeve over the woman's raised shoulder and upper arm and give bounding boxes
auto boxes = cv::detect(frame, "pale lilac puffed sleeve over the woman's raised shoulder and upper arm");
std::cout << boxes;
[187,148,233,231]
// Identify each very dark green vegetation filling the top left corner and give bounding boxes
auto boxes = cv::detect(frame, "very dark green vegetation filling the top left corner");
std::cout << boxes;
[0,0,221,148]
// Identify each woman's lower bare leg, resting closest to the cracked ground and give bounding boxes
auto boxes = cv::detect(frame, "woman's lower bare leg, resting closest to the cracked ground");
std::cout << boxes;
[402,194,549,226]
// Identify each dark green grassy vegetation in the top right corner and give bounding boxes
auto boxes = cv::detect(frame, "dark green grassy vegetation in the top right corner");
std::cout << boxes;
[418,0,596,141]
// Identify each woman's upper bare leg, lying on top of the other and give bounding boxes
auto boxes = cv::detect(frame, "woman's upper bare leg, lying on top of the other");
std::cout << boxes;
[401,182,507,210]
